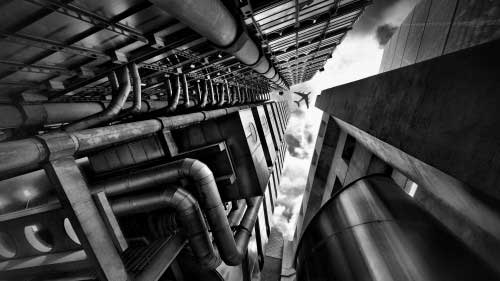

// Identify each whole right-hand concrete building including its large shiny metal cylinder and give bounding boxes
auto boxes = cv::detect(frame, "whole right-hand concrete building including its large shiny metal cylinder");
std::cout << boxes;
[294,0,500,280]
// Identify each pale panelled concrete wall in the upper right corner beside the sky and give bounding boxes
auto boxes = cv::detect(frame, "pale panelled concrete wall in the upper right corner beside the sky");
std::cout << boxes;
[380,0,500,72]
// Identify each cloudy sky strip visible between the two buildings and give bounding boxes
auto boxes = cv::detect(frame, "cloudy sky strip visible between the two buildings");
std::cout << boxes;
[272,0,418,240]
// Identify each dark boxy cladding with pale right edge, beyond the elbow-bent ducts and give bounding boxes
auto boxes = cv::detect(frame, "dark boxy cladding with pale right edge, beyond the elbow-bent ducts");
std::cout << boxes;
[172,109,269,201]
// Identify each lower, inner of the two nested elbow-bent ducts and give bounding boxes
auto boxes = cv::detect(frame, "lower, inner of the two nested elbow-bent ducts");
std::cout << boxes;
[110,186,221,269]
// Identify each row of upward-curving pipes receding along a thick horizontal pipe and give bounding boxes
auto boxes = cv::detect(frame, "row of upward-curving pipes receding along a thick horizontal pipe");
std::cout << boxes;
[0,63,270,132]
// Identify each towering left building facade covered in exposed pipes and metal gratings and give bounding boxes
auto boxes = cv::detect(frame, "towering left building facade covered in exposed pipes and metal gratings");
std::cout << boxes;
[0,0,370,281]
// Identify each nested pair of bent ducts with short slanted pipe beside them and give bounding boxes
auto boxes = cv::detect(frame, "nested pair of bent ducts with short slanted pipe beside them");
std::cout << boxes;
[93,158,263,269]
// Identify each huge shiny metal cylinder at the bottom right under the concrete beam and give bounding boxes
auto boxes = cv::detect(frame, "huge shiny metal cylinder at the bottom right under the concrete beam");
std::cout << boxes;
[296,175,500,281]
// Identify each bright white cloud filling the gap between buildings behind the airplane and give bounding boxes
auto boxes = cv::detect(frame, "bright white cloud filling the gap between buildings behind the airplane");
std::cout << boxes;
[272,35,383,240]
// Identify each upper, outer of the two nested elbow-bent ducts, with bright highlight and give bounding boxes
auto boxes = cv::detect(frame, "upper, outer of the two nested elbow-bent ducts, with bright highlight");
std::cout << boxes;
[95,158,243,265]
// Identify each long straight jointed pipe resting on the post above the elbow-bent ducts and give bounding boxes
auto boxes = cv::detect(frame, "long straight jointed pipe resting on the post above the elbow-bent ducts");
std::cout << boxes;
[0,106,256,179]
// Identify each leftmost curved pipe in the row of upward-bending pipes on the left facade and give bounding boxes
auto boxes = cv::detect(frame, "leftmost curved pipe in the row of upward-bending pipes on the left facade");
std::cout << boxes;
[62,67,130,132]
